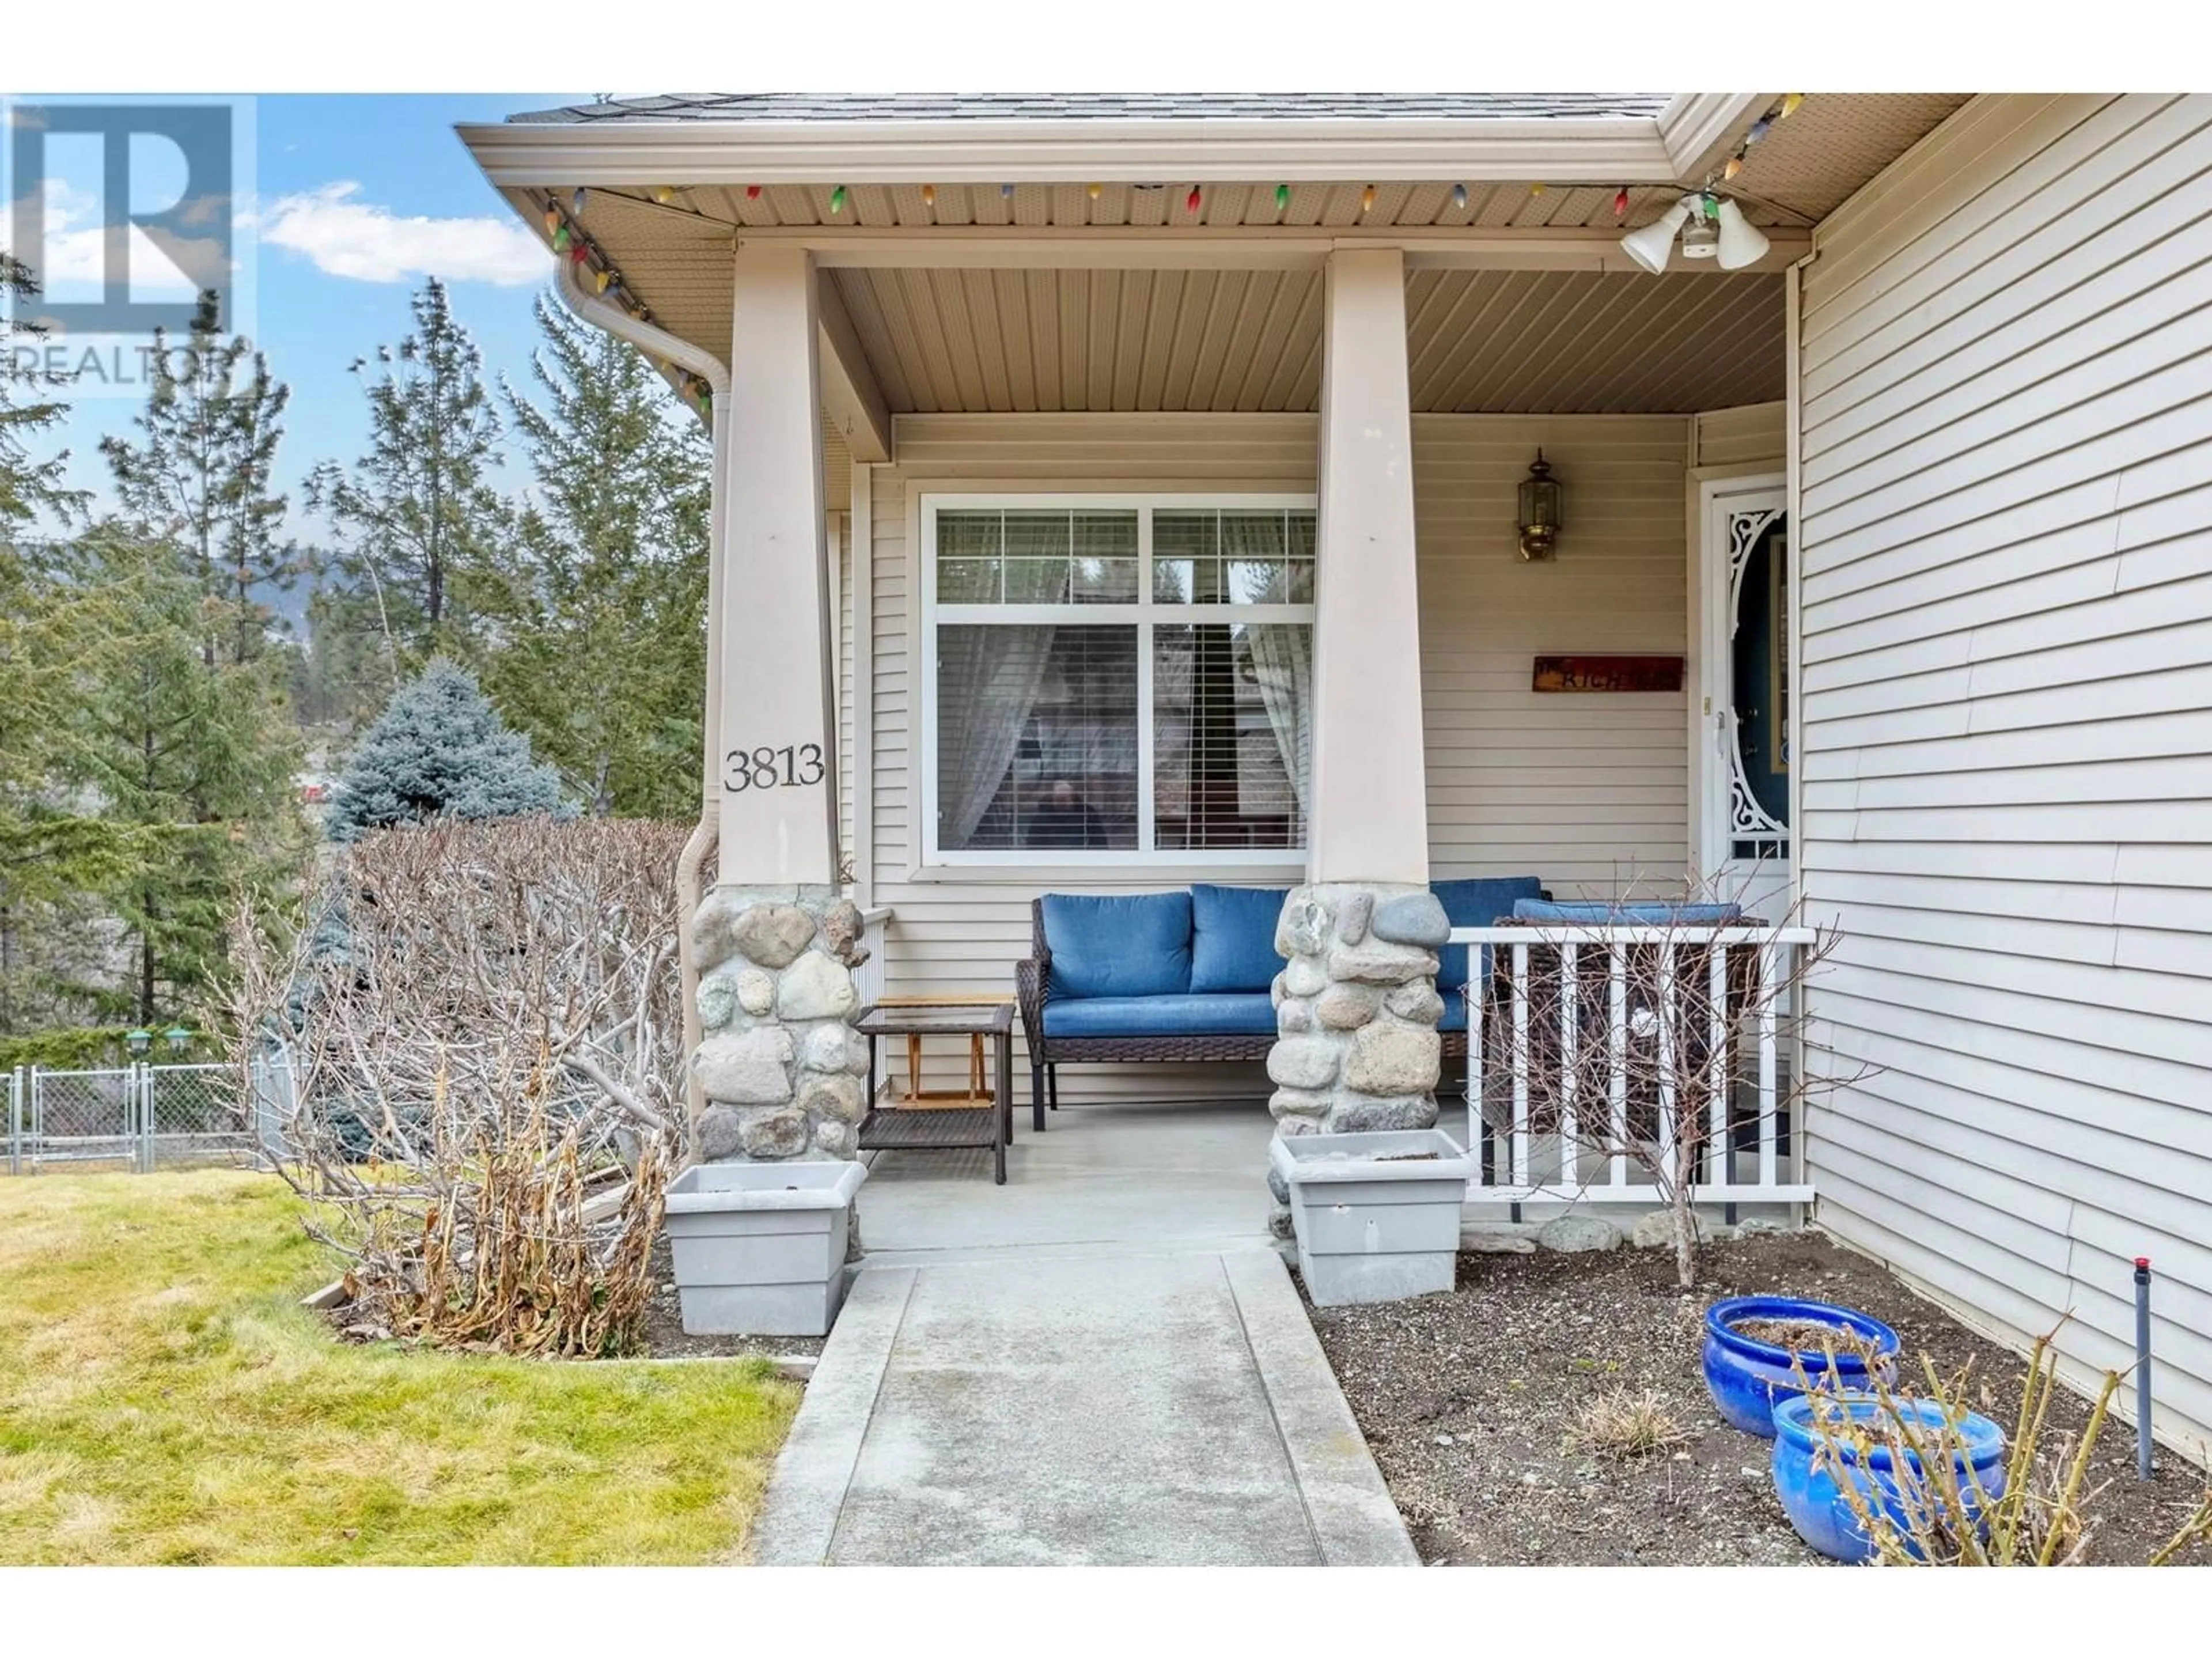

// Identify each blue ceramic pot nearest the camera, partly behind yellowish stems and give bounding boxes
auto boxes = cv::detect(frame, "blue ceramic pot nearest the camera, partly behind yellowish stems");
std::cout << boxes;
[1774,1393,2004,1562]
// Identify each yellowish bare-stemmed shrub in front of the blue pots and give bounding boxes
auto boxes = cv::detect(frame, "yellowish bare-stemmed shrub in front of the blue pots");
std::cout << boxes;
[1798,1330,2212,1566]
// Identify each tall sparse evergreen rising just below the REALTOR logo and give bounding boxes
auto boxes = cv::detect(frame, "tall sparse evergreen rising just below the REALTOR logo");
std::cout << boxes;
[100,294,298,668]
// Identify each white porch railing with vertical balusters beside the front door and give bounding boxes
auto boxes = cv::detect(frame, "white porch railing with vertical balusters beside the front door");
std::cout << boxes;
[1451,925,1816,1208]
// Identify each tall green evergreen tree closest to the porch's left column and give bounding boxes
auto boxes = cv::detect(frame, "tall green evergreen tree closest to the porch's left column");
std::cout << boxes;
[467,298,712,819]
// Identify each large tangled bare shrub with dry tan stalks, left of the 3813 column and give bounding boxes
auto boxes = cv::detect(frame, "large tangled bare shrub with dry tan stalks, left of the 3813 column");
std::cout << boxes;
[234,819,685,1356]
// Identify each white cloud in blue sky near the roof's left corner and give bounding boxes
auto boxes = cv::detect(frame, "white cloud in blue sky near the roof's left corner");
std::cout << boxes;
[261,181,553,287]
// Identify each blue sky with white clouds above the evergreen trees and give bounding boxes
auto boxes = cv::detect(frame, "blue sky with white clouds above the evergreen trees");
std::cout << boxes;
[0,93,584,537]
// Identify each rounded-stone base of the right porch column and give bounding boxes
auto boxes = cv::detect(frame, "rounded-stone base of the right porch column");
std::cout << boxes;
[1267,882,1451,1237]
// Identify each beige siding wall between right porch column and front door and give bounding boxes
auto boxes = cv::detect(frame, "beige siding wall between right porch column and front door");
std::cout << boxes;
[1414,416,1690,898]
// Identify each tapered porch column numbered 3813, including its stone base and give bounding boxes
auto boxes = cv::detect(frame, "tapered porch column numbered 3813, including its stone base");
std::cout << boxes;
[692,243,867,1161]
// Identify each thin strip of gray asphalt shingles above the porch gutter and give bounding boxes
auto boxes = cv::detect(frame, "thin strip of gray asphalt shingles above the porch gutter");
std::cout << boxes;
[509,93,1670,124]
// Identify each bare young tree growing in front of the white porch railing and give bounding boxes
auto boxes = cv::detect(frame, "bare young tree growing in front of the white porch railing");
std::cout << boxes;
[1482,887,1862,1290]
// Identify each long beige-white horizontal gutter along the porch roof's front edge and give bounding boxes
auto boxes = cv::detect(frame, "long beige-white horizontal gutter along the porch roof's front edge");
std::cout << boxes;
[458,111,1725,188]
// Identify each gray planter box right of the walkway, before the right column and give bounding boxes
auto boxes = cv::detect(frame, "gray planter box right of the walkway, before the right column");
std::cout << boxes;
[1267,1128,1475,1307]
